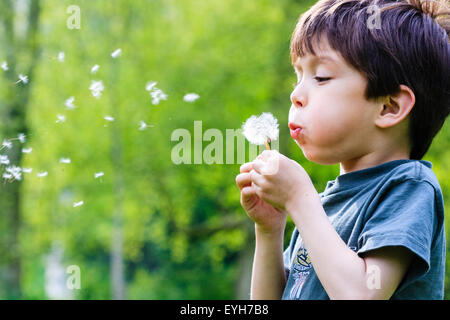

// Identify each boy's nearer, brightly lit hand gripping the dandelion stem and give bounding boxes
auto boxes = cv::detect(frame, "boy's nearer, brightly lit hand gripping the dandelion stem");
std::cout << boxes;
[250,150,318,213]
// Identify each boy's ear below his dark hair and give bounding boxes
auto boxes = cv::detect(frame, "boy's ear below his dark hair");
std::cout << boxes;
[375,84,416,128]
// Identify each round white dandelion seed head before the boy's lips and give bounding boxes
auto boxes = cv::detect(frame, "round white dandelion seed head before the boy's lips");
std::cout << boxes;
[242,112,279,150]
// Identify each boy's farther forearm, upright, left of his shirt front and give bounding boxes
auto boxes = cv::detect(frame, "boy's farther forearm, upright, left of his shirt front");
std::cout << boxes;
[250,226,286,300]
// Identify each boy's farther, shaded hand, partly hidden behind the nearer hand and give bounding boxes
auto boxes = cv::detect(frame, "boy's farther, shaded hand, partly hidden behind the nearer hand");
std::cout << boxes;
[236,162,287,234]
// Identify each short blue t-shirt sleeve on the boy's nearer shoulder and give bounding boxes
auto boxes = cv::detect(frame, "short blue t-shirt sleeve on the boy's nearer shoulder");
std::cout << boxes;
[357,179,437,284]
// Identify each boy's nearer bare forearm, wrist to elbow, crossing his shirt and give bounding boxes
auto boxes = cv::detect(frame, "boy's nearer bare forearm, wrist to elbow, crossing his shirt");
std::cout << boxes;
[289,195,368,299]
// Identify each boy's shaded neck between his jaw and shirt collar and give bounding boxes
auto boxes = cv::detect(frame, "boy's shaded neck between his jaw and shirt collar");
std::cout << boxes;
[340,150,409,174]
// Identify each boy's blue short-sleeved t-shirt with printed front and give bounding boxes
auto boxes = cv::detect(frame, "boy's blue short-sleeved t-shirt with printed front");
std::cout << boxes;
[283,160,445,300]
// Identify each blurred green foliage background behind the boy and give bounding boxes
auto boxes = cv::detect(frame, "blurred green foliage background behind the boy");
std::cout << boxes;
[0,0,450,299]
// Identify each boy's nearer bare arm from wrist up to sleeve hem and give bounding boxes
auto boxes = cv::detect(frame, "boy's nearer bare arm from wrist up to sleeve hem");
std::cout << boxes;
[288,193,412,299]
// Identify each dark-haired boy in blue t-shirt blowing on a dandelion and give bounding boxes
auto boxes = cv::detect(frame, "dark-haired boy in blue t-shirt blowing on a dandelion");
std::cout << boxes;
[236,0,450,299]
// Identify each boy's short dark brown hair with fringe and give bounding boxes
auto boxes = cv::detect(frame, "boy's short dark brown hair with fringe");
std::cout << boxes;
[290,0,450,159]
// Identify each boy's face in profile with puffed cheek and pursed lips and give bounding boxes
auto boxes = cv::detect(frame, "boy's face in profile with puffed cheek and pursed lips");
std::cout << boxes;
[289,43,383,164]
